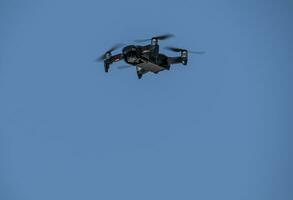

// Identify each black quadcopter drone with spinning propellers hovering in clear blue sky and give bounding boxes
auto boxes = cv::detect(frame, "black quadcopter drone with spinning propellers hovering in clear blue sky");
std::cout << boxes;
[97,34,204,79]
